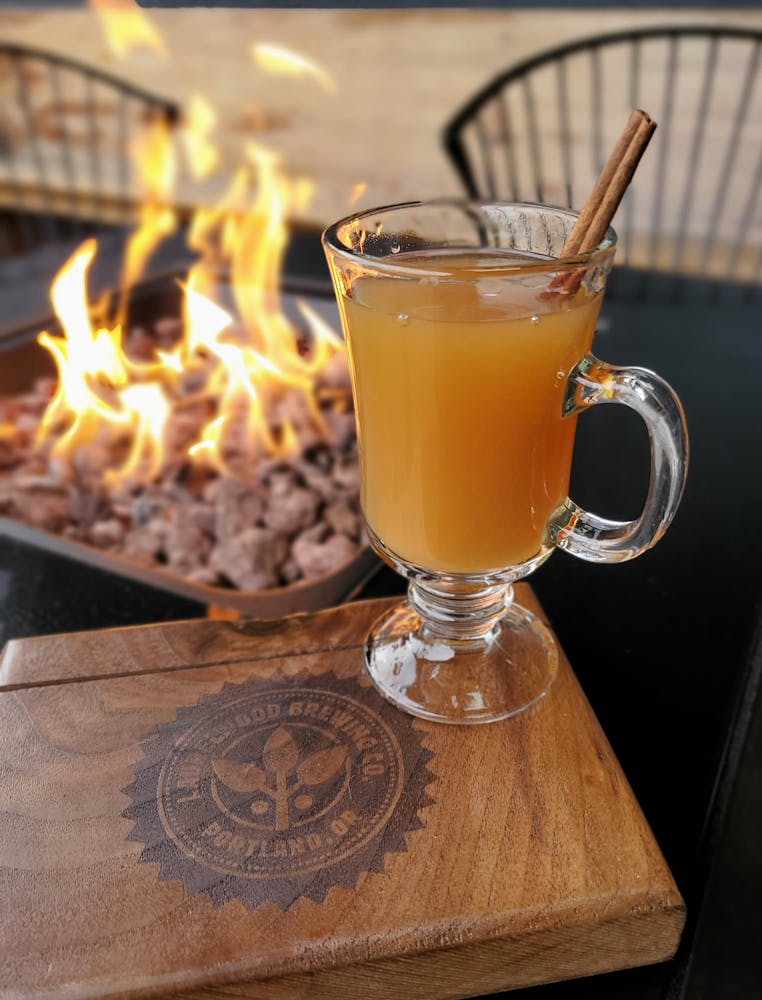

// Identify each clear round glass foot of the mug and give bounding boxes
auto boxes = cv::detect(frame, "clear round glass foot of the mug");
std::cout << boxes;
[365,585,558,725]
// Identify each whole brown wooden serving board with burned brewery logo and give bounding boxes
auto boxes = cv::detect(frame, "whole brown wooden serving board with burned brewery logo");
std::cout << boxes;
[0,587,684,1000]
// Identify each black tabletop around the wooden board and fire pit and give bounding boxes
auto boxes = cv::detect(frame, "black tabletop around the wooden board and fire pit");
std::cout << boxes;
[0,243,762,1000]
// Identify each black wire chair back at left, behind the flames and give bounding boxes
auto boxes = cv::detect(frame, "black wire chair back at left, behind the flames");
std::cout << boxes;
[0,43,180,255]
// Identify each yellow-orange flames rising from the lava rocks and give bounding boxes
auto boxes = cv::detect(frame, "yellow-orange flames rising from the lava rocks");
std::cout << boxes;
[32,46,348,485]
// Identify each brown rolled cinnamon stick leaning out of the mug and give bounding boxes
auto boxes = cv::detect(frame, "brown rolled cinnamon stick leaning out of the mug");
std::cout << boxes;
[550,108,656,292]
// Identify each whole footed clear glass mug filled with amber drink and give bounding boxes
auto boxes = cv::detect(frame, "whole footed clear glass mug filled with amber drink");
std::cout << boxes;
[323,201,688,723]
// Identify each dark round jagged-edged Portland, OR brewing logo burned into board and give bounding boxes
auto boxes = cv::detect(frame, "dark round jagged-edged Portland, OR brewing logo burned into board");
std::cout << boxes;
[123,674,434,910]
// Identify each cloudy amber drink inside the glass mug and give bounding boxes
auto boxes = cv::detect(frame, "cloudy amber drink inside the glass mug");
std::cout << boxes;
[341,254,601,573]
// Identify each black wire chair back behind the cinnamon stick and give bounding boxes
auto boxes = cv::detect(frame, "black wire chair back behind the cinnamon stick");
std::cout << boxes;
[442,25,762,283]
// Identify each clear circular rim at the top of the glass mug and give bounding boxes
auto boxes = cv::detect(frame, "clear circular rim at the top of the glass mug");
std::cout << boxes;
[321,198,617,279]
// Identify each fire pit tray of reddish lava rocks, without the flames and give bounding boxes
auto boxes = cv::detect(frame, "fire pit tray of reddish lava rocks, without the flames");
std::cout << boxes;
[0,276,377,615]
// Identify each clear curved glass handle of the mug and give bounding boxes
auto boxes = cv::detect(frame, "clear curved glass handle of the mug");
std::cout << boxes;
[548,354,688,563]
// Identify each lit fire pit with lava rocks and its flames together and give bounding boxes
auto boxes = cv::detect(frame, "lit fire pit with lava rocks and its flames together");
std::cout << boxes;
[0,116,375,614]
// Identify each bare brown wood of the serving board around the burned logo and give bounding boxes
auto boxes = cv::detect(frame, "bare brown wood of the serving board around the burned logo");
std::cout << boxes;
[0,587,684,1000]
